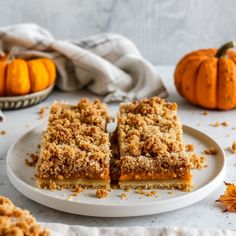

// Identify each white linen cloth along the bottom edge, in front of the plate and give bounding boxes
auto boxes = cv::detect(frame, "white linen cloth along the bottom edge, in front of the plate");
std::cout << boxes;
[41,223,236,236]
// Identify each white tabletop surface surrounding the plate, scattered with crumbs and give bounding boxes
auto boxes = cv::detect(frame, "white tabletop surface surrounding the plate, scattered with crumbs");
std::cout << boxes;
[0,66,236,230]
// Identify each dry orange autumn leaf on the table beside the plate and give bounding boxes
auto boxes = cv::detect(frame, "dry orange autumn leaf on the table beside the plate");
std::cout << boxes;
[216,182,236,212]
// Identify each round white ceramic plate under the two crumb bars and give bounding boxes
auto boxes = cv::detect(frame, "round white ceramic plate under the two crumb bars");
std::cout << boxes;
[7,125,225,217]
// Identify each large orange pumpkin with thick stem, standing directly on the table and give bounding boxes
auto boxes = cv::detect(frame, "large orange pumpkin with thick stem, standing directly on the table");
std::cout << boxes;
[174,42,236,110]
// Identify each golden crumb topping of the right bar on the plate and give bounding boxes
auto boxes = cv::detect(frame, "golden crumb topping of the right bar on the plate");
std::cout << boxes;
[118,97,190,179]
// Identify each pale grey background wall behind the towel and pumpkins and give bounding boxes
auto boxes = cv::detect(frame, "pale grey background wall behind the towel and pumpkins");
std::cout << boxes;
[0,0,236,64]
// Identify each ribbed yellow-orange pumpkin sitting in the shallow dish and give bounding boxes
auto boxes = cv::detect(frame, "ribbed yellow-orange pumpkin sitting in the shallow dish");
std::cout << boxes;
[0,51,56,96]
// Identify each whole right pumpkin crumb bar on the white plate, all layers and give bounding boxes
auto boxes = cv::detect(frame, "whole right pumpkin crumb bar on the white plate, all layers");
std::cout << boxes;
[118,97,192,191]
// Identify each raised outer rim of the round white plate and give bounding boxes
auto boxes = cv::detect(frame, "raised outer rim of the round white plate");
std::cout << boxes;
[6,122,226,217]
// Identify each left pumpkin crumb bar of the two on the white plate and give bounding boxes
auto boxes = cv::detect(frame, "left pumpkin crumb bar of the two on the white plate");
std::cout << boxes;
[36,98,111,189]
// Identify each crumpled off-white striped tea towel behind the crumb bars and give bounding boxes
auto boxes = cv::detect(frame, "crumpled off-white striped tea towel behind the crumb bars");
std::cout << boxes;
[0,24,167,102]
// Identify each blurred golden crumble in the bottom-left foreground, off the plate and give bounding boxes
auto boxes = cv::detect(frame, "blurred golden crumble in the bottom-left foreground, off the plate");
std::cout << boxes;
[0,196,50,236]
